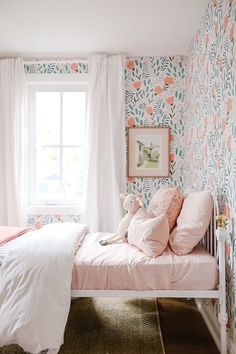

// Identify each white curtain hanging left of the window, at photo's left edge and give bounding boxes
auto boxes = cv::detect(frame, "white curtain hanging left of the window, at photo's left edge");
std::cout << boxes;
[0,58,25,226]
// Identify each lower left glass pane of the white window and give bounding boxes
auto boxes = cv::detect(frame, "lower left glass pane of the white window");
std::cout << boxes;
[36,147,62,200]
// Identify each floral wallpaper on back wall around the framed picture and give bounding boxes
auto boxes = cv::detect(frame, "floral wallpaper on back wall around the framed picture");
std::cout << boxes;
[125,56,185,205]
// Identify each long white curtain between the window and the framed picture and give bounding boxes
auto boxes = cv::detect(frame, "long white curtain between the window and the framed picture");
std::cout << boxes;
[84,55,126,232]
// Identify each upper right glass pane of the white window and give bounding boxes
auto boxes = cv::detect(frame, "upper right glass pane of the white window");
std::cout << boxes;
[63,92,86,145]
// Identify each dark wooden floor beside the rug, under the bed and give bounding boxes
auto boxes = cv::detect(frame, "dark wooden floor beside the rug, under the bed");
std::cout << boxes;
[158,299,219,354]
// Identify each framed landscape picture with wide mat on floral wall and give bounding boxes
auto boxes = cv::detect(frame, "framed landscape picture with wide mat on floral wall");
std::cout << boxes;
[128,127,169,177]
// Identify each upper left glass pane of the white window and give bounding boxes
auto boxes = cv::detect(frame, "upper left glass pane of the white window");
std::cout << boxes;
[36,92,60,145]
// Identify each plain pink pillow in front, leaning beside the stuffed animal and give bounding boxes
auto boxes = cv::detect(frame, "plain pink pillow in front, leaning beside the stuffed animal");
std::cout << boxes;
[128,209,169,257]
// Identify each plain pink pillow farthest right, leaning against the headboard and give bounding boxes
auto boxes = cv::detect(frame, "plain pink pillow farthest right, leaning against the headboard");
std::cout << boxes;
[169,191,213,255]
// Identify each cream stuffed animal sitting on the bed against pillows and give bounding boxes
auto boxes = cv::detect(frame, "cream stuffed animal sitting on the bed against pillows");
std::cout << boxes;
[99,193,143,246]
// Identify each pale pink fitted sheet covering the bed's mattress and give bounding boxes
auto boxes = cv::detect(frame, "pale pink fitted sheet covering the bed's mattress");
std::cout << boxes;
[72,233,218,290]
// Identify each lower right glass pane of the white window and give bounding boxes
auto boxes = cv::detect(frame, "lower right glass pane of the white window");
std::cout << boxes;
[63,147,84,199]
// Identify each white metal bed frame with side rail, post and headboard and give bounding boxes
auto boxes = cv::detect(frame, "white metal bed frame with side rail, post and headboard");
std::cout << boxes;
[71,193,228,354]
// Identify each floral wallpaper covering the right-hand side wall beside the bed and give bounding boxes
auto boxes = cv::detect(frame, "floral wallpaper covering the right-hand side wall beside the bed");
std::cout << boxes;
[183,0,236,343]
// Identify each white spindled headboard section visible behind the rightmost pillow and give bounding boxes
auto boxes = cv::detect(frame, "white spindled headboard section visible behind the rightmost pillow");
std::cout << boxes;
[201,191,219,258]
